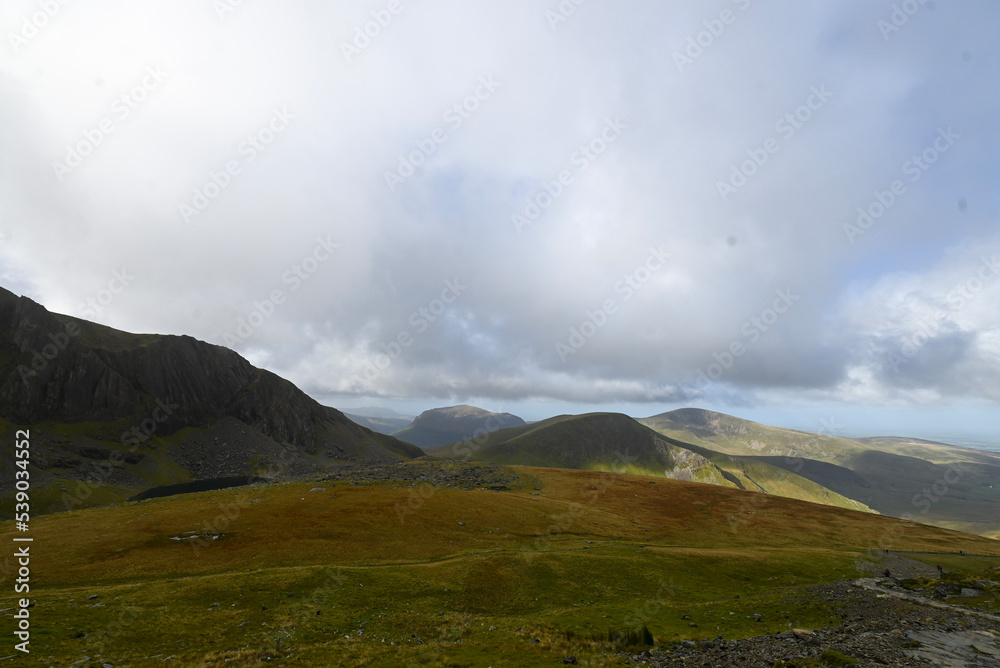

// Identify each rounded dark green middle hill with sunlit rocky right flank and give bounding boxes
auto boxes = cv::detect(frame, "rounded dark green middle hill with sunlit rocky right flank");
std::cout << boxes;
[428,413,870,511]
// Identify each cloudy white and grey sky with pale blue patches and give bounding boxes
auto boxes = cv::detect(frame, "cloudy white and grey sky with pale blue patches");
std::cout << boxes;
[0,0,1000,447]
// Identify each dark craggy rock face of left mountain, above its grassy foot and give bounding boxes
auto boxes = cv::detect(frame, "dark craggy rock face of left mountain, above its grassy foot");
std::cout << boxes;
[0,290,419,455]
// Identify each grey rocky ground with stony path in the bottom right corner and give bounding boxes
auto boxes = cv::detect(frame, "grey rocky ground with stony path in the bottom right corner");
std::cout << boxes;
[625,555,1000,668]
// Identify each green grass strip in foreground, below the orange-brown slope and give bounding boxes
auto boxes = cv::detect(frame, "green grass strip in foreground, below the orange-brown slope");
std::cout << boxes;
[19,546,850,666]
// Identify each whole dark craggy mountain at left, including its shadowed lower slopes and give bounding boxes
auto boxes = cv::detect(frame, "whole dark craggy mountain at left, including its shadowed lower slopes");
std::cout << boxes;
[0,288,423,512]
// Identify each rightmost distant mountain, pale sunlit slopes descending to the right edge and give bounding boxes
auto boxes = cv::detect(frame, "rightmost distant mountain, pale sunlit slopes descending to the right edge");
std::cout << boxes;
[640,408,1000,538]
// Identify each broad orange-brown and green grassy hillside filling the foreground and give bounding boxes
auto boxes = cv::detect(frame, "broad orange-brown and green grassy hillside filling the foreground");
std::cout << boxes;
[0,468,1000,667]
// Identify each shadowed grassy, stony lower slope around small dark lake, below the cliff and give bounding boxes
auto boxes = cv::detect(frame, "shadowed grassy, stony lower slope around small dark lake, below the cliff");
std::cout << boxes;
[0,418,424,519]
